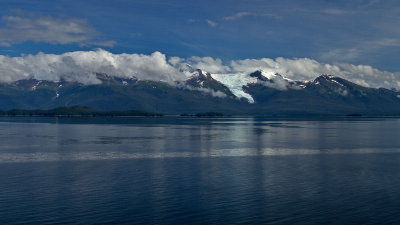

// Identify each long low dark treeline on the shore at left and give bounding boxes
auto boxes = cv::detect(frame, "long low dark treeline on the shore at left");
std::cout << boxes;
[0,106,162,117]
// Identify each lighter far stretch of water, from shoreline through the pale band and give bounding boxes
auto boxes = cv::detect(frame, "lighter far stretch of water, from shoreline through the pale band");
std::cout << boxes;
[0,117,400,163]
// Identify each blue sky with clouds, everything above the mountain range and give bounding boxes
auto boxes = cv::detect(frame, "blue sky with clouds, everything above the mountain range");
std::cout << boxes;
[0,0,400,88]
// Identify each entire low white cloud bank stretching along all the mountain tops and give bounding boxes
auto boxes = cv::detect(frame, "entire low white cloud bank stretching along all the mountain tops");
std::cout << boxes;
[0,49,400,89]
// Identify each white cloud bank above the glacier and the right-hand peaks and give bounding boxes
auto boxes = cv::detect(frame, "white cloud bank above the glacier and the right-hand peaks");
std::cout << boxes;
[185,57,400,89]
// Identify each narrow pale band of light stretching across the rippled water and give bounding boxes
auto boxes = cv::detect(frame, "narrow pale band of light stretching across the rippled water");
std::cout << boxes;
[0,148,400,163]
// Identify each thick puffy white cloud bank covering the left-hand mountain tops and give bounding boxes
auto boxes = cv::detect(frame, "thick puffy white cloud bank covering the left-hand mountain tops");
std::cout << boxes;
[0,49,184,84]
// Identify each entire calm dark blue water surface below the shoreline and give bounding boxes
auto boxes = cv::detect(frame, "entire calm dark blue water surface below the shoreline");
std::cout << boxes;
[0,118,400,224]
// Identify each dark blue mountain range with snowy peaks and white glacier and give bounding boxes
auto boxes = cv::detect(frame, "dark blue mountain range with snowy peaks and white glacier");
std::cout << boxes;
[0,70,400,115]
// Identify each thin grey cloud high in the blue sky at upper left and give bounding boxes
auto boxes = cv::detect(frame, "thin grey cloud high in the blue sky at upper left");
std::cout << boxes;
[0,15,115,47]
